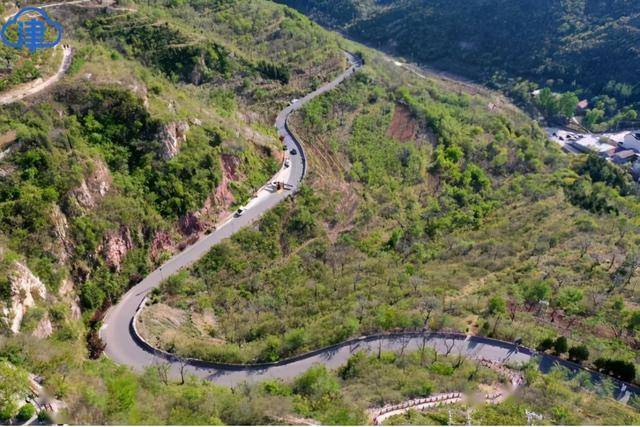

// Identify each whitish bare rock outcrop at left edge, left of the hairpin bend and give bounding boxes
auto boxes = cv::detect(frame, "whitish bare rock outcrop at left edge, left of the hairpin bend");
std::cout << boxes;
[0,262,47,334]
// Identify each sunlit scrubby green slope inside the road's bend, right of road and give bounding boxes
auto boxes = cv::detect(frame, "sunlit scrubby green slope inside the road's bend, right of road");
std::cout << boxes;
[143,40,640,392]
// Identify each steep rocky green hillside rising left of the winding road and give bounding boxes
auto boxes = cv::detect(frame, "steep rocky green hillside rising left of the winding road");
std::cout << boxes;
[0,2,344,344]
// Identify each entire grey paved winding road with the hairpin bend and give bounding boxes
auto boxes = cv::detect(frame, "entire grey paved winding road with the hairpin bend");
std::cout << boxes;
[90,54,640,402]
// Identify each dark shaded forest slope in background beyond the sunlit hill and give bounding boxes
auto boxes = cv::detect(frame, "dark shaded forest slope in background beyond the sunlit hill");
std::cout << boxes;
[279,0,640,129]
